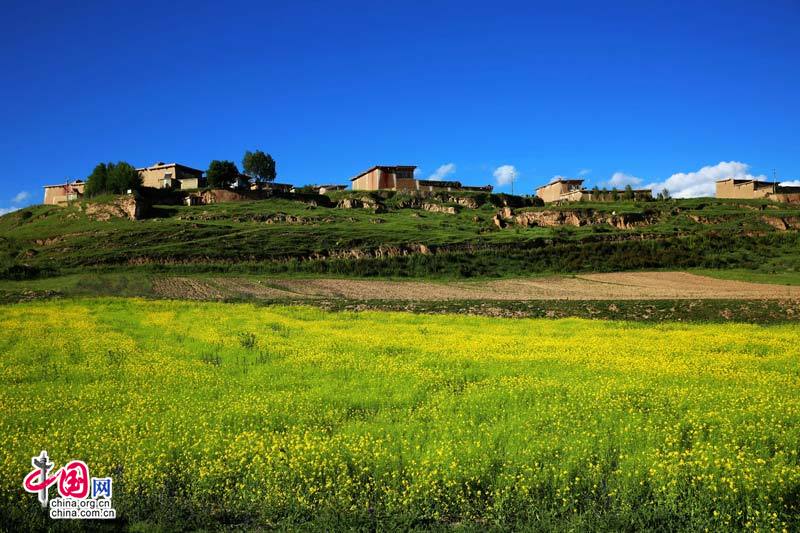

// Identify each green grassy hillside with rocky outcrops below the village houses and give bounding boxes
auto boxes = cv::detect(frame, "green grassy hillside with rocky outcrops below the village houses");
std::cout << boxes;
[0,193,800,279]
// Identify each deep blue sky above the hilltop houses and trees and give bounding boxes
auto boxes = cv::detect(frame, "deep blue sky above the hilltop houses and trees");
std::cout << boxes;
[0,0,800,209]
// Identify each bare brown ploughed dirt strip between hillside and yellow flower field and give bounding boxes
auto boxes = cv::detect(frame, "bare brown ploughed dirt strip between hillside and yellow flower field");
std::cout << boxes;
[153,272,800,301]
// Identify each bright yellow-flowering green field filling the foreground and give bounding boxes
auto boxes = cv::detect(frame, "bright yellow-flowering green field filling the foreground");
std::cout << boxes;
[0,298,800,531]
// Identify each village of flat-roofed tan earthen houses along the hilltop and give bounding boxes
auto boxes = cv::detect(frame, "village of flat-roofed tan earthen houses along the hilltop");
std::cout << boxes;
[43,161,800,205]
